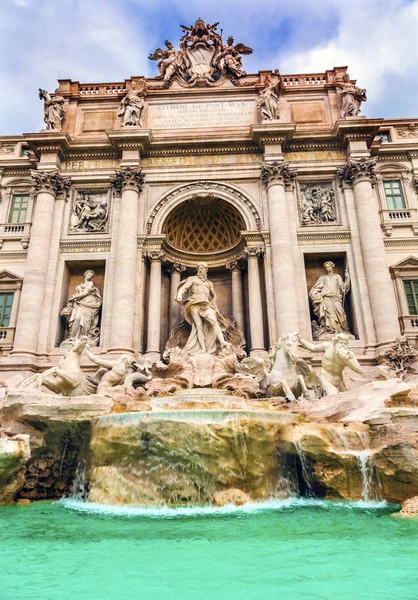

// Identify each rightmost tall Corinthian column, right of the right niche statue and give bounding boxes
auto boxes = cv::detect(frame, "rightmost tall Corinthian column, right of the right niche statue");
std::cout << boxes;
[338,158,400,344]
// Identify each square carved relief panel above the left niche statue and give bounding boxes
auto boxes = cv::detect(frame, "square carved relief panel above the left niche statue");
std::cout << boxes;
[68,187,110,234]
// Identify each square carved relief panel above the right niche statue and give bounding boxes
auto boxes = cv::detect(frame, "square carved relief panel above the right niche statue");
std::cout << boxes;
[298,181,340,227]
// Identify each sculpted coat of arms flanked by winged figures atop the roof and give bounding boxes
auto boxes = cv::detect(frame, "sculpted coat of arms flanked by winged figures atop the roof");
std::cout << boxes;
[148,19,252,85]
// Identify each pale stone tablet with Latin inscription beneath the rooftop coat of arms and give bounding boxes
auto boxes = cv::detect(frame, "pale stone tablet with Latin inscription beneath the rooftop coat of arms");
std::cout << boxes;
[147,101,256,129]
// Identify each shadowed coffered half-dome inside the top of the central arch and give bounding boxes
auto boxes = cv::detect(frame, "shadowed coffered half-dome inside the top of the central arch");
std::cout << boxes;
[162,194,245,255]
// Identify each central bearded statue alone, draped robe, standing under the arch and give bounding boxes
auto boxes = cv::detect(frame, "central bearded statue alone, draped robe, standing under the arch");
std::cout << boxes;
[176,262,228,356]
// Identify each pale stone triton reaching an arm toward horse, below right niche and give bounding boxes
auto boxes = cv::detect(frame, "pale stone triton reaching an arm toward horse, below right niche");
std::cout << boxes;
[299,333,362,396]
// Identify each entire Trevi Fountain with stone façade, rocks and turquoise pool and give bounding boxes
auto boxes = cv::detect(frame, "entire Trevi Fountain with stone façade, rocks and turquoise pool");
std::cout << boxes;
[0,19,418,600]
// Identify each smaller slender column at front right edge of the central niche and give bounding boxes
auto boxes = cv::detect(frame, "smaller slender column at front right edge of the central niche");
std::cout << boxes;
[244,246,265,356]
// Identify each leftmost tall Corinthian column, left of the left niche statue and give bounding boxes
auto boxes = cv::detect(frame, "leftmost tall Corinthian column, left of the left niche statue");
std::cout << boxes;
[13,171,70,354]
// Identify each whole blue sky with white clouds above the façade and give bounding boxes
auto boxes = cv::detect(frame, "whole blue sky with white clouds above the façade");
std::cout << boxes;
[0,0,418,135]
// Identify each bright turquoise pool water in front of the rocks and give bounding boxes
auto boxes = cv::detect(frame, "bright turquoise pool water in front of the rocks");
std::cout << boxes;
[0,500,418,600]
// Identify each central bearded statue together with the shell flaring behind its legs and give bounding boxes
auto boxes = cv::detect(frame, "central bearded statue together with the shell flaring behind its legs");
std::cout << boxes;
[167,262,245,357]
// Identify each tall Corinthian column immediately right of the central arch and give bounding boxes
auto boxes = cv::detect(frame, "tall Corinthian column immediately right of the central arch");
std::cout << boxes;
[261,162,299,336]
